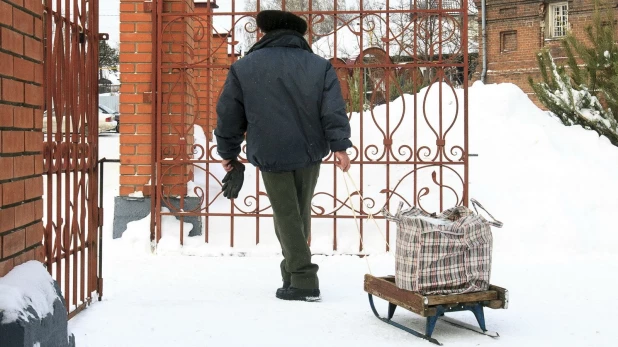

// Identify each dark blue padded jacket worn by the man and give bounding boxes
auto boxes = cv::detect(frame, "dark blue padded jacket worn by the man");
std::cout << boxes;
[215,30,352,172]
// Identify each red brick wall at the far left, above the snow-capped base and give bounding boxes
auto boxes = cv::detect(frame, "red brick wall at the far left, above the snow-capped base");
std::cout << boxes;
[0,0,45,276]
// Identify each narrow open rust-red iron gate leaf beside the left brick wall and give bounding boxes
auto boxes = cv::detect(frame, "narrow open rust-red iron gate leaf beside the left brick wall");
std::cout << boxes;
[43,0,102,317]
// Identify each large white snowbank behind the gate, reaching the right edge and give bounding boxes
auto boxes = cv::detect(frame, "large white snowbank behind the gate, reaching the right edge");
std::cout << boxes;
[113,83,618,257]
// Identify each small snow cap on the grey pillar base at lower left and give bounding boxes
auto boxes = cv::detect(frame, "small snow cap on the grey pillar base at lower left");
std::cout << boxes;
[0,261,58,324]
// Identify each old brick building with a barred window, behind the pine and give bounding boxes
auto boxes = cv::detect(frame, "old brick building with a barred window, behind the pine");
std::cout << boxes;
[475,0,618,98]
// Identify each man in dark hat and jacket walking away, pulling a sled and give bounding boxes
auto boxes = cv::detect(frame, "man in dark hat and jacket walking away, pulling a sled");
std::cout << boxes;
[215,11,352,301]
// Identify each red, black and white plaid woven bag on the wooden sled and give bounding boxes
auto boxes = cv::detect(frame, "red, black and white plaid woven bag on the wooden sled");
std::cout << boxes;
[383,199,502,295]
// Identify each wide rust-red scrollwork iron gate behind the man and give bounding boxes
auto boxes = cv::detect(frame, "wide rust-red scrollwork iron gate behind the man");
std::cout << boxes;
[152,0,469,253]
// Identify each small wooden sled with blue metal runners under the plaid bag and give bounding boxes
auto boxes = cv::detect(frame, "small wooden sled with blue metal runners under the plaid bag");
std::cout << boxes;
[365,274,509,346]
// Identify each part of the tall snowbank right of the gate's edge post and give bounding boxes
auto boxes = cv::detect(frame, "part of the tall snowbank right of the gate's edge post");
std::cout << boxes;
[469,83,618,258]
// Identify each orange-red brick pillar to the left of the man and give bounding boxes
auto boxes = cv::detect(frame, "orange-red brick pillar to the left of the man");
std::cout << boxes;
[120,0,197,196]
